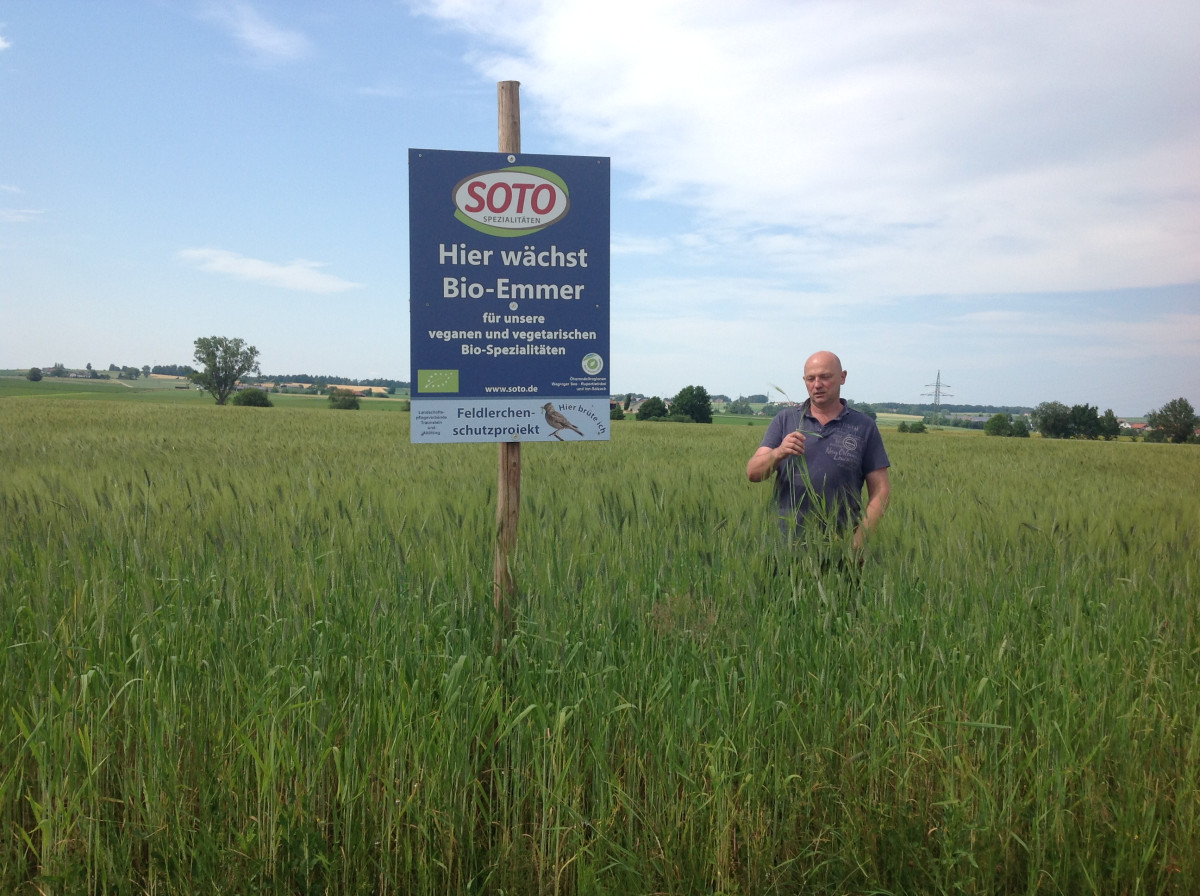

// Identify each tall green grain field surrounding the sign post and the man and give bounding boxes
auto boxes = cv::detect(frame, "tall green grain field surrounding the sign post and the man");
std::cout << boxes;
[0,390,1200,896]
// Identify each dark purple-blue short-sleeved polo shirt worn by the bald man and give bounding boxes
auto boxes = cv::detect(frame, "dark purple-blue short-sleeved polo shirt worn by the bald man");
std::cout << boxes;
[761,399,892,537]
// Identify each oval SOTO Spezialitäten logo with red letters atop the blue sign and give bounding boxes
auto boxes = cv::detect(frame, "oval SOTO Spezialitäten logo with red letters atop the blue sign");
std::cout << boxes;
[454,166,571,236]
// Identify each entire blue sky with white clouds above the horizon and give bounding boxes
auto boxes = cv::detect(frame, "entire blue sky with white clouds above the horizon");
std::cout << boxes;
[0,0,1200,415]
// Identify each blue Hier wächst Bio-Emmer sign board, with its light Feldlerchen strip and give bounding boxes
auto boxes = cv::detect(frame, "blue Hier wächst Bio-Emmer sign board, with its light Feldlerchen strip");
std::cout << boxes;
[408,149,610,443]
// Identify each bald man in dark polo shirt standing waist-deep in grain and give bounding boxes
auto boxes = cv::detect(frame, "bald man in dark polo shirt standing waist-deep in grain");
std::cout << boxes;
[746,351,892,551]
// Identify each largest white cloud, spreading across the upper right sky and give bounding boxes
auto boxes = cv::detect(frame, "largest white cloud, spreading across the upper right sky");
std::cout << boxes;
[427,0,1200,295]
